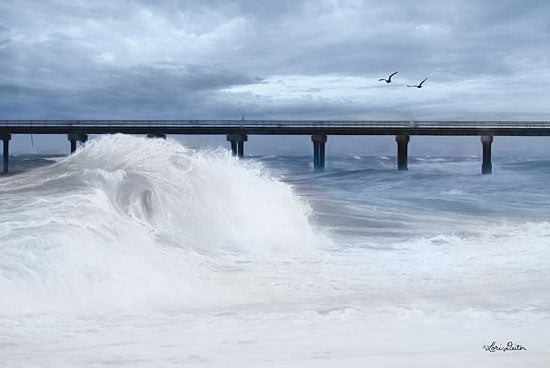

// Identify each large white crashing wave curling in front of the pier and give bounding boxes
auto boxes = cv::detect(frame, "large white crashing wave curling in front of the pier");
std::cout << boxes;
[0,135,323,313]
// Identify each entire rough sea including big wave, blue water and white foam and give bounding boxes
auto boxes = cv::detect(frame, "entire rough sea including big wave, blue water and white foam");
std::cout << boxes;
[0,135,550,367]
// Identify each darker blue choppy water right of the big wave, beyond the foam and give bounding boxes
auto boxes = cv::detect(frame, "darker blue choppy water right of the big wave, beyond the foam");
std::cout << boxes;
[256,152,550,242]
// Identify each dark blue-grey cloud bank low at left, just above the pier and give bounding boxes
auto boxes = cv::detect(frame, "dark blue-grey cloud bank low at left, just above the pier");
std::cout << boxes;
[0,63,264,119]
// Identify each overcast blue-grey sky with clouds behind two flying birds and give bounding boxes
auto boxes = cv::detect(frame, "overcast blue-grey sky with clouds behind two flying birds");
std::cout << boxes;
[0,0,550,153]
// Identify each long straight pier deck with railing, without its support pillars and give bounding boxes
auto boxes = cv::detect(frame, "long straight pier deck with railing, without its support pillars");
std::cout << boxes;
[0,120,550,136]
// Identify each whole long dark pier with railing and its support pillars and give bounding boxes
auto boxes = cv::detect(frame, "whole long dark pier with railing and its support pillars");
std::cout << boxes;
[0,120,550,174]
